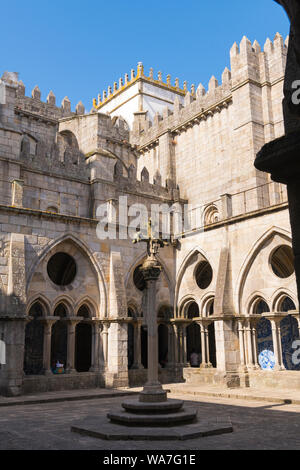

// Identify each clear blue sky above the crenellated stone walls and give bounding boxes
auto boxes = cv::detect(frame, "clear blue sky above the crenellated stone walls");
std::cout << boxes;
[0,0,289,110]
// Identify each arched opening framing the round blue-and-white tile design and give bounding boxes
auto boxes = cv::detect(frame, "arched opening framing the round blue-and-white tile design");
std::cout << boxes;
[253,299,275,370]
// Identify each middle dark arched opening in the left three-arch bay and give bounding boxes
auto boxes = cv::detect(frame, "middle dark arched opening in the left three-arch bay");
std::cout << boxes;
[51,304,68,370]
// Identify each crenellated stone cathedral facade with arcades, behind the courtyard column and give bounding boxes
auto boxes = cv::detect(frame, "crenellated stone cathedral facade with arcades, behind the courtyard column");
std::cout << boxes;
[0,34,300,395]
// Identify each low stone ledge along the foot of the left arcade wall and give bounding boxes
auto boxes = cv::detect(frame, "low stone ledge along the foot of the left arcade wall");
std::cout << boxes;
[0,388,139,407]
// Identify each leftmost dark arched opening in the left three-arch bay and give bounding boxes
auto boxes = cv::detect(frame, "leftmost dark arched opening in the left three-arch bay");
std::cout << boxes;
[24,302,44,375]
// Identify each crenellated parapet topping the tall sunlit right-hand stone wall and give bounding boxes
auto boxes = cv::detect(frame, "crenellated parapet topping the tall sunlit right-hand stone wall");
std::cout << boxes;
[131,33,289,149]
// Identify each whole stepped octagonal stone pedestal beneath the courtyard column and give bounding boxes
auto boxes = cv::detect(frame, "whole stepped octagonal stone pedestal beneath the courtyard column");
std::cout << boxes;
[71,400,233,441]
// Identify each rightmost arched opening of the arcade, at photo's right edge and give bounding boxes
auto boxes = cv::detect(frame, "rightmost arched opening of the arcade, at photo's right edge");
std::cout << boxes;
[279,296,300,370]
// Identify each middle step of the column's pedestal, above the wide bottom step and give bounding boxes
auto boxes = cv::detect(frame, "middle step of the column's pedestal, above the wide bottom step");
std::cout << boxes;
[107,408,197,427]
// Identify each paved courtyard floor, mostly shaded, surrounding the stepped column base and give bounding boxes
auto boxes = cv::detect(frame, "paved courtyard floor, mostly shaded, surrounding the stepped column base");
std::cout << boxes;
[0,390,300,451]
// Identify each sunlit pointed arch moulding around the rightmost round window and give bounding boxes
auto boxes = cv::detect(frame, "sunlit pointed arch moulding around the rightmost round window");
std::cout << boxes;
[234,226,292,312]
